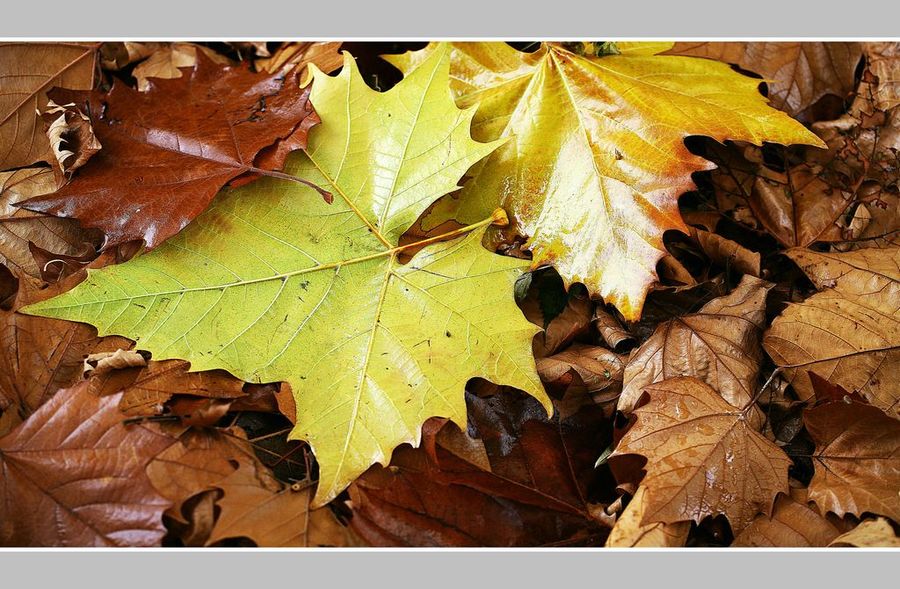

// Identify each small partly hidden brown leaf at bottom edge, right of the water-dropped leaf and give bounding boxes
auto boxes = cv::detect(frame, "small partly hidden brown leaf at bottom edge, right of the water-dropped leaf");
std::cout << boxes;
[731,495,840,548]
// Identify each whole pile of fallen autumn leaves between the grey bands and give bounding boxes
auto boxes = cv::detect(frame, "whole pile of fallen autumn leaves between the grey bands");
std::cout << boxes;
[0,42,900,547]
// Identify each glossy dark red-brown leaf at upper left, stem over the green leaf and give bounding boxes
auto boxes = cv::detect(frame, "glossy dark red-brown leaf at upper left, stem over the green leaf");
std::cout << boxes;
[20,54,330,248]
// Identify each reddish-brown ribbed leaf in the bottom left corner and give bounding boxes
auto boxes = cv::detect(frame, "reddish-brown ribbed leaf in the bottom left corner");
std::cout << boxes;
[0,383,173,547]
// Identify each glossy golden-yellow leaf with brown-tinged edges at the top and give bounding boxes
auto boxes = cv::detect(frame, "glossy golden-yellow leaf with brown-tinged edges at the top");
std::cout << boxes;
[388,43,823,320]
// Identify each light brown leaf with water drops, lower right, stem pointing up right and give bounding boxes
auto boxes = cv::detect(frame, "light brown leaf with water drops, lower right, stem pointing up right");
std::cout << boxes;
[611,377,791,534]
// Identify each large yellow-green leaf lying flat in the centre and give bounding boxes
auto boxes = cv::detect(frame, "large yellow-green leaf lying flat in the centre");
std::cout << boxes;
[27,49,551,505]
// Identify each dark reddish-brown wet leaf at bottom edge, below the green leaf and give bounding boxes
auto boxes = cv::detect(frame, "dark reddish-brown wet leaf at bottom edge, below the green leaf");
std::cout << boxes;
[350,393,608,546]
